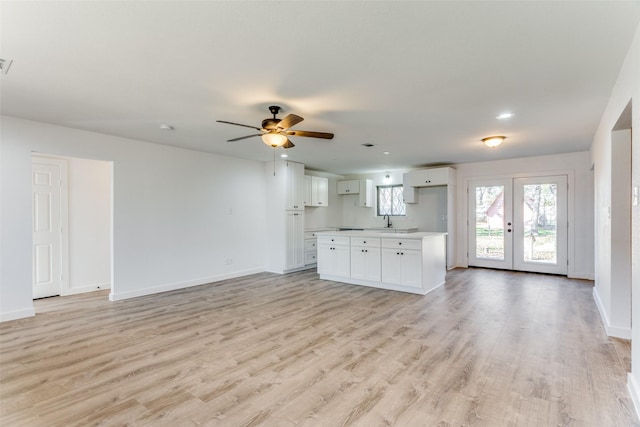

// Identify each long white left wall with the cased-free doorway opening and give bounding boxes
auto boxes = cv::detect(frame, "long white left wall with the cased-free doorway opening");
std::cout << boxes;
[0,116,265,320]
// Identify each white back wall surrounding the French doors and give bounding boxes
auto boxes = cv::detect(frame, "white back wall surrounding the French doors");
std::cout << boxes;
[455,152,594,279]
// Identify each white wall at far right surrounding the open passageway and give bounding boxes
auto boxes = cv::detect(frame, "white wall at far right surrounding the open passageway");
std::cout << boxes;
[591,22,640,412]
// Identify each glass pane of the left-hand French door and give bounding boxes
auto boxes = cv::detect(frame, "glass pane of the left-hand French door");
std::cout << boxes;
[475,185,504,260]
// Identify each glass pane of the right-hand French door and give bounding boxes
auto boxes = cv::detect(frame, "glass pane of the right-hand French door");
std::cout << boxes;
[522,184,558,264]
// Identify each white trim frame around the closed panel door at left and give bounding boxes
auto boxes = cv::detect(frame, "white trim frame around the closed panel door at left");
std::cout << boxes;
[30,152,69,298]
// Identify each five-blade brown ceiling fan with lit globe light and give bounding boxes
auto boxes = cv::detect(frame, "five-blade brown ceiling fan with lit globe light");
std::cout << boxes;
[216,105,333,148]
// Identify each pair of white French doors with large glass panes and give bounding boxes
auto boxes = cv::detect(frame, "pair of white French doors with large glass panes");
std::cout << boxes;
[468,175,567,274]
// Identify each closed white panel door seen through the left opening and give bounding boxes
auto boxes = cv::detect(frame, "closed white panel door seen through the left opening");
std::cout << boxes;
[32,163,62,298]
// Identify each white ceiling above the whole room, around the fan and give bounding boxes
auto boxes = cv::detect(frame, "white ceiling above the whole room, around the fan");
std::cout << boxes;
[0,0,640,174]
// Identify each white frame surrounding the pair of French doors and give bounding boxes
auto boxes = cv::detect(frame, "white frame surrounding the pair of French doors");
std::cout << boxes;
[458,169,576,277]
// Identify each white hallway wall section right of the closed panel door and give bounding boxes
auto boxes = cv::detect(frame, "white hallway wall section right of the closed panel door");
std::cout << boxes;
[65,158,111,294]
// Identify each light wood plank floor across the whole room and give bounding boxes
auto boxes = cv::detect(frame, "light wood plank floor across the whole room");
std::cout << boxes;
[0,269,639,427]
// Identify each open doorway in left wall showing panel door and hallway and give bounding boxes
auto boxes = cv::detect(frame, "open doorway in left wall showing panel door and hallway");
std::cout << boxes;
[32,153,113,299]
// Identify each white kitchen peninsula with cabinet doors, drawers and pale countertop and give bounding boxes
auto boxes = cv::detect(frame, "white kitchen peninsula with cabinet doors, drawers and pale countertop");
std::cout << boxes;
[317,229,447,295]
